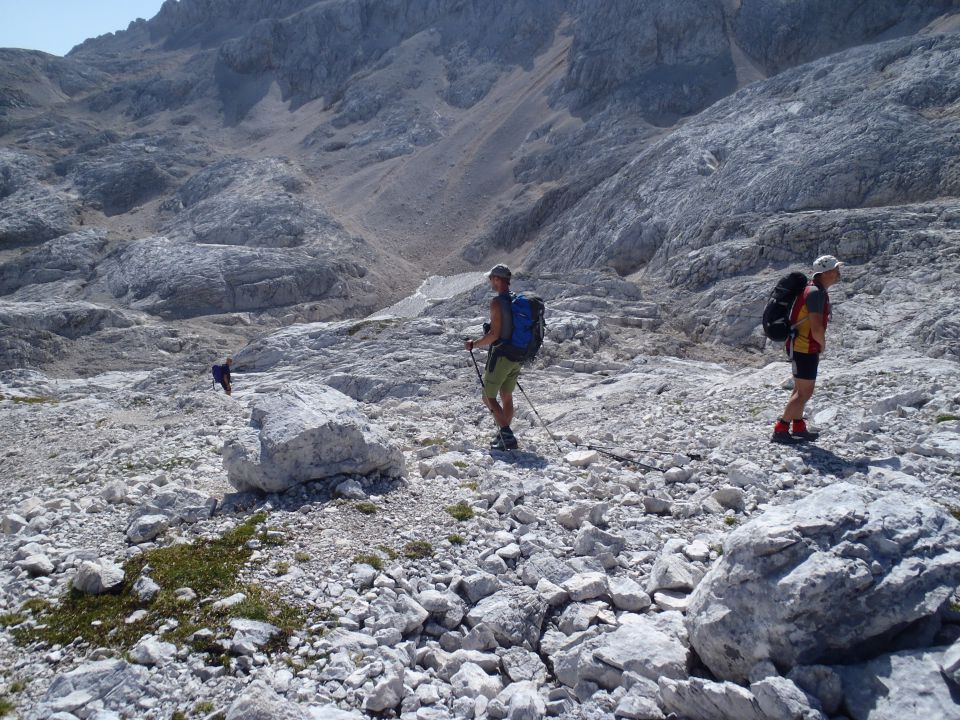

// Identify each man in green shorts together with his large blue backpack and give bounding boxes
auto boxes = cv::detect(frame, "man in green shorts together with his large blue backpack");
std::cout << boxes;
[463,265,544,450]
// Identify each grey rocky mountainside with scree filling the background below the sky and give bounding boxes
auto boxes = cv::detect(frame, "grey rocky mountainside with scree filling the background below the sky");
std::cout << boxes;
[0,0,957,367]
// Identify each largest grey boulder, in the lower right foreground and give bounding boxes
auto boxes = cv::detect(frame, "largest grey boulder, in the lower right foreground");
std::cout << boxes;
[687,483,960,681]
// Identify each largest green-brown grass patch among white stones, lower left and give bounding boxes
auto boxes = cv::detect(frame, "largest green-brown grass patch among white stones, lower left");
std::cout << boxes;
[13,513,304,652]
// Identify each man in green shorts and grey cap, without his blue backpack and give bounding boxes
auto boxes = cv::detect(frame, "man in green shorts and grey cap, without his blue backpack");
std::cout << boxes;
[463,265,521,450]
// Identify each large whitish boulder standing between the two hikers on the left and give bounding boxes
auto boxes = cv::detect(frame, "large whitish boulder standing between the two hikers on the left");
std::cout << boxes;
[223,383,403,492]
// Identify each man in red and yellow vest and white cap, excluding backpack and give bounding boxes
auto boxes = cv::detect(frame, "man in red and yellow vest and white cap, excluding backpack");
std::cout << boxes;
[771,255,843,443]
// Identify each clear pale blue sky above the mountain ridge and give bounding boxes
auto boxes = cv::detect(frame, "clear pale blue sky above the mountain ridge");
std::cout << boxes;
[0,0,163,55]
